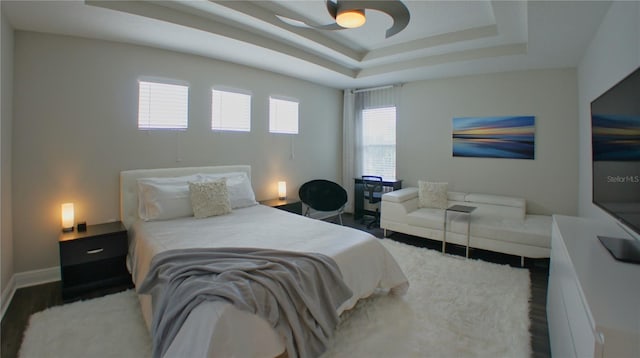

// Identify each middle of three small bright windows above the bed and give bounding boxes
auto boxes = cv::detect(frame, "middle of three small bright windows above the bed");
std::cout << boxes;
[211,89,251,132]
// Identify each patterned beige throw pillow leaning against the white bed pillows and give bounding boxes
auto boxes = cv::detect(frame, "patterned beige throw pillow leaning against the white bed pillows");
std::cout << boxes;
[189,178,231,219]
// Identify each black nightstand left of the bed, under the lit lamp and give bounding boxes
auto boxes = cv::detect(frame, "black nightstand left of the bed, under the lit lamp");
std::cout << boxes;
[58,221,133,301]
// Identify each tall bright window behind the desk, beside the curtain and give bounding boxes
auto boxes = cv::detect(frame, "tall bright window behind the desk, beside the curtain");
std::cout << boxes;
[362,107,396,179]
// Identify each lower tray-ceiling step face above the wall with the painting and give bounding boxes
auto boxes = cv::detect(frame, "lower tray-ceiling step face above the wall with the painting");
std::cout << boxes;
[356,43,527,78]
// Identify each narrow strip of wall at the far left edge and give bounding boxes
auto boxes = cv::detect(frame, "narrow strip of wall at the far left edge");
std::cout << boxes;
[0,7,14,300]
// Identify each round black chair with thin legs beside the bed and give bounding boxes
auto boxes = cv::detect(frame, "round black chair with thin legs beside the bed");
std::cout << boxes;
[298,179,347,225]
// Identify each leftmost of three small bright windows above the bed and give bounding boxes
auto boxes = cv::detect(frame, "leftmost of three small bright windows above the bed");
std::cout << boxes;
[138,81,189,129]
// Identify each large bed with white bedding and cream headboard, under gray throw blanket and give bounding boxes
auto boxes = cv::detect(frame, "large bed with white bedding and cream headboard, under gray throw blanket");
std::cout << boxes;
[120,165,409,357]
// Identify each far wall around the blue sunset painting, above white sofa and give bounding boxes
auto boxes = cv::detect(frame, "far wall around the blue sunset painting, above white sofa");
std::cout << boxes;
[397,69,578,215]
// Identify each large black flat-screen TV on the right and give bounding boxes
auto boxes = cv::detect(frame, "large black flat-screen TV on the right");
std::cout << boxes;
[591,68,640,236]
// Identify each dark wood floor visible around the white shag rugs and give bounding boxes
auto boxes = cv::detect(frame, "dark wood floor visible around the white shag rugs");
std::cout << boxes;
[0,215,551,358]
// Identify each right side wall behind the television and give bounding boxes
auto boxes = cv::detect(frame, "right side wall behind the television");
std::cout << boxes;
[578,1,640,224]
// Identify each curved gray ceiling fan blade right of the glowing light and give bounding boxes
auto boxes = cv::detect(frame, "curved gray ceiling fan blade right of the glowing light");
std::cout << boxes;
[336,0,411,38]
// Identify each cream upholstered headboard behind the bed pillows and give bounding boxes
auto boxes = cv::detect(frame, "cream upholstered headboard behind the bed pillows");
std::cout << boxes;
[120,165,251,229]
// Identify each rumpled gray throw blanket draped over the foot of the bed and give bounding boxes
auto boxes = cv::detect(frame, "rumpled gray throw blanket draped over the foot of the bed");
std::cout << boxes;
[138,248,352,358]
